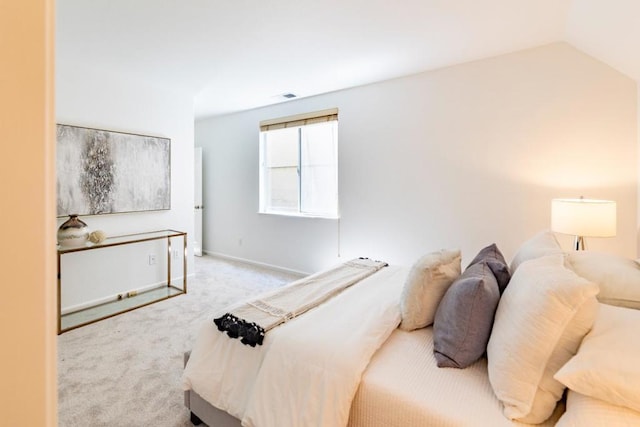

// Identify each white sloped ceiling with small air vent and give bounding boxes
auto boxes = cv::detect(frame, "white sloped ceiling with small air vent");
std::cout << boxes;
[56,0,640,119]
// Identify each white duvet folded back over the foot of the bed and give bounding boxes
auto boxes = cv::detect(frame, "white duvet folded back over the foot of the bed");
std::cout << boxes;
[183,266,407,427]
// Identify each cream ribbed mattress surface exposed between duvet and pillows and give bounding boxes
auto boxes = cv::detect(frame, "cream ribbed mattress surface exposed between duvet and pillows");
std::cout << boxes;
[349,327,564,427]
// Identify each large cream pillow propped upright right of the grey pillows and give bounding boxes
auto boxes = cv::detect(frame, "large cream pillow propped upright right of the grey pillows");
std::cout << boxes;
[487,255,598,424]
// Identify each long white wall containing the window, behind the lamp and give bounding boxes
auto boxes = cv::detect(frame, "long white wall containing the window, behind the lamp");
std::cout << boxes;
[196,43,638,271]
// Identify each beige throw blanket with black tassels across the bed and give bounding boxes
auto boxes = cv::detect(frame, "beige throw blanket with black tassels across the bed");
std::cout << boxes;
[213,258,388,347]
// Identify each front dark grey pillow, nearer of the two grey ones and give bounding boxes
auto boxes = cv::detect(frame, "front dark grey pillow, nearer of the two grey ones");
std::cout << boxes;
[433,262,500,368]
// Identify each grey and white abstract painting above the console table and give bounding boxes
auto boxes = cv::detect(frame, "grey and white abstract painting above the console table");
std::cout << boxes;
[56,125,171,216]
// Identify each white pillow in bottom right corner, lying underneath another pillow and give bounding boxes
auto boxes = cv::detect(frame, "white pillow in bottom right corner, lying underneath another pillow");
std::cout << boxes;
[556,390,640,427]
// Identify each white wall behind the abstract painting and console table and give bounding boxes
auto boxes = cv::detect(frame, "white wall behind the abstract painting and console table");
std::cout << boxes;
[56,61,194,309]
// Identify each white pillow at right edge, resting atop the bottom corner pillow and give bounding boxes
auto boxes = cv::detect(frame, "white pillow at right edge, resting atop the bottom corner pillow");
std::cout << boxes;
[555,304,640,411]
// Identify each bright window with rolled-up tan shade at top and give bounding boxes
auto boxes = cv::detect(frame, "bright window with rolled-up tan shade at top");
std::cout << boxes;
[260,109,338,218]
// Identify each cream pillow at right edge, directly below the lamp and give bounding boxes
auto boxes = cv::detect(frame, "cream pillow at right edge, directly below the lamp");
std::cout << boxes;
[568,251,640,309]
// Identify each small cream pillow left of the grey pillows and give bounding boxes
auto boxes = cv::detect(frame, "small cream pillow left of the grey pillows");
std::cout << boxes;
[400,249,461,331]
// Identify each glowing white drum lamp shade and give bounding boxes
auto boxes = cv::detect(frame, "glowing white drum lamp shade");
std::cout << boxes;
[551,199,616,237]
